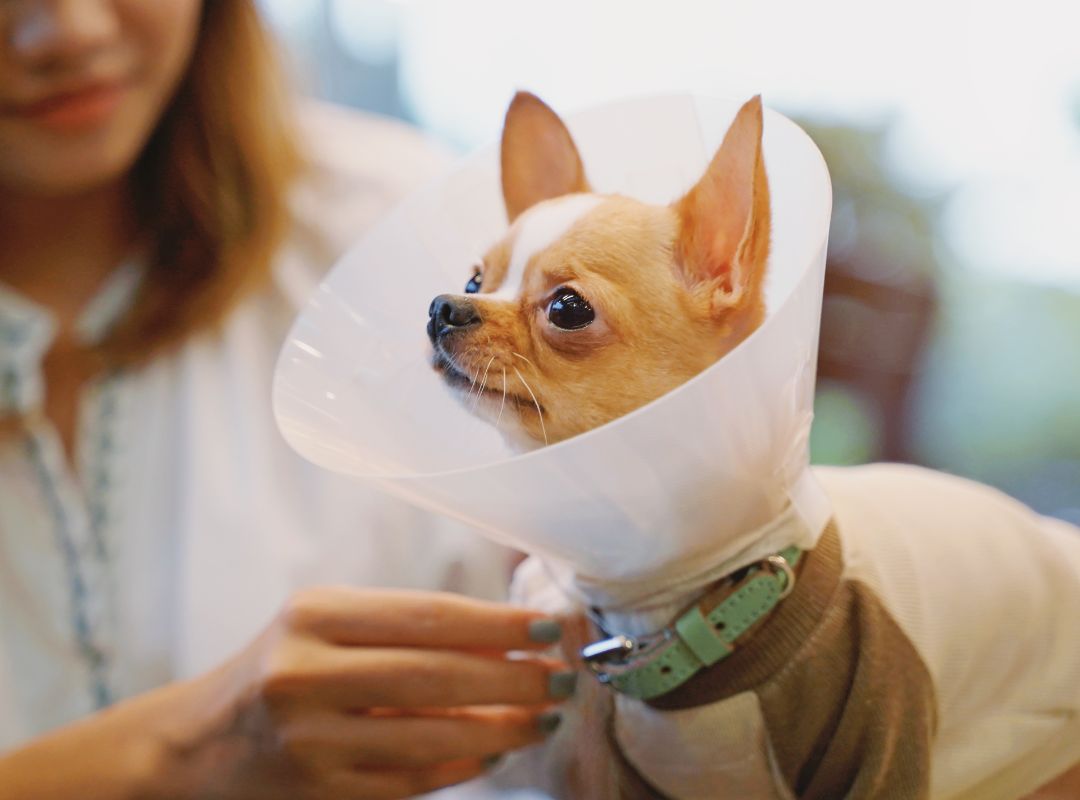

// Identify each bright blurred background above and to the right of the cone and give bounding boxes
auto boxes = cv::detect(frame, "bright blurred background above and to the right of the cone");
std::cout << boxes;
[260,0,1080,523]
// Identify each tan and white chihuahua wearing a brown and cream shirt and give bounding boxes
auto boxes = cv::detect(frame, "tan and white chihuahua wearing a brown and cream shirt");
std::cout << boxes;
[428,93,1080,800]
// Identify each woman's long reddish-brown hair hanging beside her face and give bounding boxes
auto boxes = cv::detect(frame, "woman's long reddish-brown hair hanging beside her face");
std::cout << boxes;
[99,0,301,364]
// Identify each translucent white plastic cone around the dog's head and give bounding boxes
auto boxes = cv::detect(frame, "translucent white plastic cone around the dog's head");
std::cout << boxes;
[273,95,831,582]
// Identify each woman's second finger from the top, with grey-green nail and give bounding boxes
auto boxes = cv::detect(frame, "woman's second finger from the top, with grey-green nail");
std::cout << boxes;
[270,647,577,709]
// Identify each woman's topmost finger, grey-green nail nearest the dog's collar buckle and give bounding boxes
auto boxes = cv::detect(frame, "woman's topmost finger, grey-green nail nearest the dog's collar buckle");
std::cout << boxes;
[284,586,562,652]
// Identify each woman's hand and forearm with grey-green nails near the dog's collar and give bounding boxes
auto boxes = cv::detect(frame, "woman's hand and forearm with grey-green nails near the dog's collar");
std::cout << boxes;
[0,588,575,800]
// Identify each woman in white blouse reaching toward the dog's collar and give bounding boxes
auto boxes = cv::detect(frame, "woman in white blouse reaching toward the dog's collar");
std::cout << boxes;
[0,0,572,800]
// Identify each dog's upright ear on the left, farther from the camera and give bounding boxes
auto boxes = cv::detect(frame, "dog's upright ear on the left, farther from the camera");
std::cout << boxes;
[502,92,589,222]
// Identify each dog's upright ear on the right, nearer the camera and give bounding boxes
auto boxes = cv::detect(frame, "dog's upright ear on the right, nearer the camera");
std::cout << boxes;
[674,95,770,313]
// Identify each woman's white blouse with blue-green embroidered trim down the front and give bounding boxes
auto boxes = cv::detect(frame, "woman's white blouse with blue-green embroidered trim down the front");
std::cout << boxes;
[0,106,509,750]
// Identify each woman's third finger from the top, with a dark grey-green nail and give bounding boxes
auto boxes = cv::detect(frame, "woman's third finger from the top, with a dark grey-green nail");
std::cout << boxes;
[281,707,562,770]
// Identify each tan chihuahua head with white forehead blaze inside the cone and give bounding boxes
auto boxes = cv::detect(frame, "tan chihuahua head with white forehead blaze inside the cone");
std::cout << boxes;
[428,93,770,447]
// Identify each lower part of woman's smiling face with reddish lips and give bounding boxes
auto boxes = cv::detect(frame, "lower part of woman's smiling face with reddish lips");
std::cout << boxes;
[0,0,201,196]
